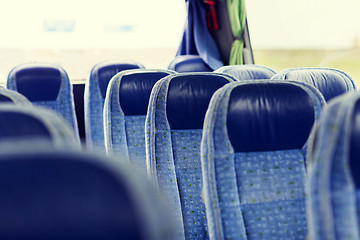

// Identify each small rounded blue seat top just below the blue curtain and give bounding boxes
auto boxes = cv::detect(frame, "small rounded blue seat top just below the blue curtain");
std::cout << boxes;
[168,55,213,73]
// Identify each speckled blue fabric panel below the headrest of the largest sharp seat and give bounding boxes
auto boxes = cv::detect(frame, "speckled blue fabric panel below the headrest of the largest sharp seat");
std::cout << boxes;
[235,150,306,240]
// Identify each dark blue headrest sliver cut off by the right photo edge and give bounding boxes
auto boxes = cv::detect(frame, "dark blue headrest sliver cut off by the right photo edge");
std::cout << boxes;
[350,100,360,189]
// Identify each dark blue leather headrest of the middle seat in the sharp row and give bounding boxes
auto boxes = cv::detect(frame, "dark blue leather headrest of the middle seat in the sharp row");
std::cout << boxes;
[166,75,229,129]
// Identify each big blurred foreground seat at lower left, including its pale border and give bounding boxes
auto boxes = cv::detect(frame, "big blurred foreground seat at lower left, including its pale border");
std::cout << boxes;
[0,144,174,240]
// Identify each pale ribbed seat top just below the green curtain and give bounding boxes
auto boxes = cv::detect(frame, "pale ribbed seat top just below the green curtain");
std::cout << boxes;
[214,64,276,80]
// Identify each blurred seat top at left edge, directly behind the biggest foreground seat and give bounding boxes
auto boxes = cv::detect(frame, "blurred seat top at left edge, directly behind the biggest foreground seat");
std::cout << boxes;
[0,104,80,149]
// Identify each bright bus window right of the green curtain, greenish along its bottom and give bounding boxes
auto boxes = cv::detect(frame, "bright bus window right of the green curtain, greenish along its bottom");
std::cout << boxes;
[246,0,360,86]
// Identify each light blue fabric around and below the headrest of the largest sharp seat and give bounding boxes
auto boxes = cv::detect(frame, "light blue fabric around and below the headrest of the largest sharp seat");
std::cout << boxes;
[201,80,325,240]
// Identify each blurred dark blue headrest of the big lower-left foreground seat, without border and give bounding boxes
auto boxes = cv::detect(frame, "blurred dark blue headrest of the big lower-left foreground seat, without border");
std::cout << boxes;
[0,153,141,240]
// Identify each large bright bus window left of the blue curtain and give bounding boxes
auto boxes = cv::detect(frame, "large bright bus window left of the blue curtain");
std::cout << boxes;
[0,0,186,82]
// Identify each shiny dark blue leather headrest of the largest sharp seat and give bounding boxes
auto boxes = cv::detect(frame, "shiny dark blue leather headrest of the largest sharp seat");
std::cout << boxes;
[227,83,314,152]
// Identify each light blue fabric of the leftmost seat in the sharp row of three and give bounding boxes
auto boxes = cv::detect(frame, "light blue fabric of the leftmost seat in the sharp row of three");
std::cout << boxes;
[104,69,173,171]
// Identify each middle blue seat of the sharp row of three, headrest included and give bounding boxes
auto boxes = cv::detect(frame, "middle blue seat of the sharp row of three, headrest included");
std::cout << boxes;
[145,73,235,239]
